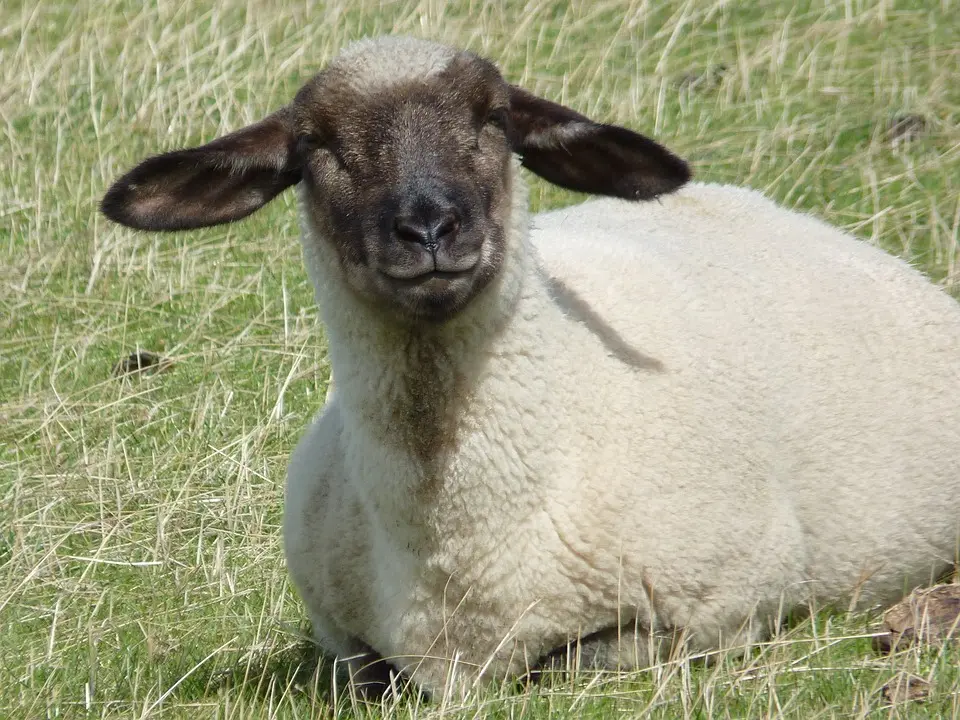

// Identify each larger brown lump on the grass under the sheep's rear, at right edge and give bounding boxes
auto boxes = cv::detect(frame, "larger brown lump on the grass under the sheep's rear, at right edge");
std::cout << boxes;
[874,585,960,652]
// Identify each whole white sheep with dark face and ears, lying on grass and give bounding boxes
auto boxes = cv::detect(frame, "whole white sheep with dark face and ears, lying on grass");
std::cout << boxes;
[103,38,960,692]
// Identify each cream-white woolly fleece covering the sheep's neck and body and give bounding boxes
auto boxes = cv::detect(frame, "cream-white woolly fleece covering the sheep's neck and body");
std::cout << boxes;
[284,167,960,692]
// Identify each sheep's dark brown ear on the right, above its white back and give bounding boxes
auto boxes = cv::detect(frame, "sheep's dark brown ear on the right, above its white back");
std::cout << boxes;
[508,86,690,200]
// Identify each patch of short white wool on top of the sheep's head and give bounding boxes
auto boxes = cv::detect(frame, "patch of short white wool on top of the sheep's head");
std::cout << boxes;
[329,36,457,93]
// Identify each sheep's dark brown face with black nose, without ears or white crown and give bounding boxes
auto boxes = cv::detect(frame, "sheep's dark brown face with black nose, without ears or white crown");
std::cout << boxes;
[293,60,511,321]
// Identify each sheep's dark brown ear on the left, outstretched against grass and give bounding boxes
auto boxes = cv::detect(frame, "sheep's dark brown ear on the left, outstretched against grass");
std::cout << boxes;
[100,110,301,230]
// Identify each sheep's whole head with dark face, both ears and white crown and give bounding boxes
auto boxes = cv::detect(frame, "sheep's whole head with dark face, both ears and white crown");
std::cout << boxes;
[103,38,689,320]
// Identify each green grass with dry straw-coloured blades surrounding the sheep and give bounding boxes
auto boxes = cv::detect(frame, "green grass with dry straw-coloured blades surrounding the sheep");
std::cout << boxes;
[0,0,960,719]
